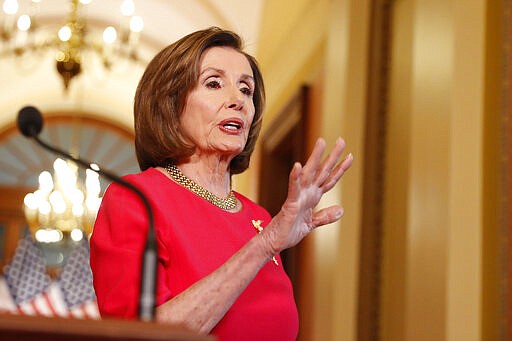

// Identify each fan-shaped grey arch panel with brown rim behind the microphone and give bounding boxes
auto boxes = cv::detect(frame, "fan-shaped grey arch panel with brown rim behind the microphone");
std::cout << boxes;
[0,116,139,189]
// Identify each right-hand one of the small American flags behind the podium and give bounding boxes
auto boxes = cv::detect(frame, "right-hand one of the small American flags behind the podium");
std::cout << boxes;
[58,240,99,318]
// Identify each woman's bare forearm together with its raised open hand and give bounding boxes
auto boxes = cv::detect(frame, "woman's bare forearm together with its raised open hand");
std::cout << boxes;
[157,135,353,333]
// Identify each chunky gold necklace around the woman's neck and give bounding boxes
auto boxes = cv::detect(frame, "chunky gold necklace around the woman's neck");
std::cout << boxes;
[165,163,237,211]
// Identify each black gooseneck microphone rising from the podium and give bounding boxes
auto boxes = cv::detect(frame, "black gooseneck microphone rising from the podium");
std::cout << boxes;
[17,106,157,321]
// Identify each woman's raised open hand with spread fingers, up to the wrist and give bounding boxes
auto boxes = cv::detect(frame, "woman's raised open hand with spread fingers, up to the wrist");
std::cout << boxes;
[264,138,354,255]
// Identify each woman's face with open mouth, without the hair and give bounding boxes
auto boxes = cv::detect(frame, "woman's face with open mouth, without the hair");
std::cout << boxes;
[180,47,255,158]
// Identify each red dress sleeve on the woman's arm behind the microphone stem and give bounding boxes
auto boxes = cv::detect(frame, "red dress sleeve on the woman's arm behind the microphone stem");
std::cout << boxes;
[91,183,170,319]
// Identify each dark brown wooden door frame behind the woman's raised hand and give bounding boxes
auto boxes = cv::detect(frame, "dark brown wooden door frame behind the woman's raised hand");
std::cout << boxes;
[259,87,319,340]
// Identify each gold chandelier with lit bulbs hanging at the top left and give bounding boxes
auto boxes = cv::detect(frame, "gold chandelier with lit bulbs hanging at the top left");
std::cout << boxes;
[0,0,143,90]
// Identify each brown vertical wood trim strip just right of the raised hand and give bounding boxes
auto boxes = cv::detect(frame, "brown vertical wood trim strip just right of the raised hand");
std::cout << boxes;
[357,0,391,341]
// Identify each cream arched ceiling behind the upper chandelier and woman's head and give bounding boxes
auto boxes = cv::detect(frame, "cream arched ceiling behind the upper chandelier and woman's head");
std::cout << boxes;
[0,0,264,129]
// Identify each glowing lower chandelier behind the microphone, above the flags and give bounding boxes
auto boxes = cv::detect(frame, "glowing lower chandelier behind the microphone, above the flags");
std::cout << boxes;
[23,158,101,244]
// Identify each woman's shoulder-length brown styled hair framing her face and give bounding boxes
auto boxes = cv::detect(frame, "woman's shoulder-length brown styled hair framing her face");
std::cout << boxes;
[134,27,265,174]
